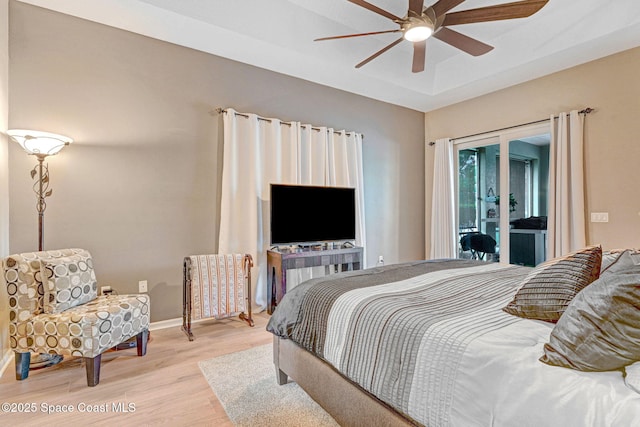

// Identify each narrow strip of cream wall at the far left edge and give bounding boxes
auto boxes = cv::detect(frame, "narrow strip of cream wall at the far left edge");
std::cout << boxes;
[0,0,10,368]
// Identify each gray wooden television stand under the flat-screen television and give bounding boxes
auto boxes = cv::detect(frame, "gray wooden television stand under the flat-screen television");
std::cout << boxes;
[267,246,363,314]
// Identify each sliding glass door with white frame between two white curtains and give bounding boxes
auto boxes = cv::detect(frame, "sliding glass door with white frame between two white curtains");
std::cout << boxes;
[454,122,550,266]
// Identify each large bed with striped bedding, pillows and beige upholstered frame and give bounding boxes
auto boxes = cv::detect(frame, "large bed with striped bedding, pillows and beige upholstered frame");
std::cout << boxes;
[267,247,640,427]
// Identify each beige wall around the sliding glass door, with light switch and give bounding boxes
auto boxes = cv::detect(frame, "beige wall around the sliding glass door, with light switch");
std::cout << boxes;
[425,48,640,253]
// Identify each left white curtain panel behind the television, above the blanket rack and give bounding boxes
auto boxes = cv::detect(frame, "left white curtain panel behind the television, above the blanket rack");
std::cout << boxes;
[218,109,298,307]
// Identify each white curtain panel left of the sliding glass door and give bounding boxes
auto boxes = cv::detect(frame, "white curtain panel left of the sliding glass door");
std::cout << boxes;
[427,138,458,259]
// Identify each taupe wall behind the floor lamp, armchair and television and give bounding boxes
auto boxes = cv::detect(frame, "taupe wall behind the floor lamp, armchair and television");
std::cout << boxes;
[9,2,424,321]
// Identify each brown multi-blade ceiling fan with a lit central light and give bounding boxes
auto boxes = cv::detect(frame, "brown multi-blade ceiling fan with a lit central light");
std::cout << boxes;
[314,0,548,73]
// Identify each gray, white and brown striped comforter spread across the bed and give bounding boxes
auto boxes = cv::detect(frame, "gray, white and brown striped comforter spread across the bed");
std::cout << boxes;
[267,260,530,426]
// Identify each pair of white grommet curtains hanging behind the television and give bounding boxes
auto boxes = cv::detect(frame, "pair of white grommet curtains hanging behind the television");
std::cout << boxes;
[218,109,366,308]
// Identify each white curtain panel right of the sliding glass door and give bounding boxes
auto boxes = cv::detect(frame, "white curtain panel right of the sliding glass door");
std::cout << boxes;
[547,110,586,259]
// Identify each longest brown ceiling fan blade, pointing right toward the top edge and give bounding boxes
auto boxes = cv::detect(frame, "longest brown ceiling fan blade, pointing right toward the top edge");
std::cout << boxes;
[442,0,549,26]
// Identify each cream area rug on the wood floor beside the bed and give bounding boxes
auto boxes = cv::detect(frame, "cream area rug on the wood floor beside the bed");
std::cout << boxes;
[198,344,338,427]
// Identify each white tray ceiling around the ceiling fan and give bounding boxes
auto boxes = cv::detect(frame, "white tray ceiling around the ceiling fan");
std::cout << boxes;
[20,0,640,111]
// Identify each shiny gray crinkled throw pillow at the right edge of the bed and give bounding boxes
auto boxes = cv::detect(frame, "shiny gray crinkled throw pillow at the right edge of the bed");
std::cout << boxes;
[540,266,640,371]
